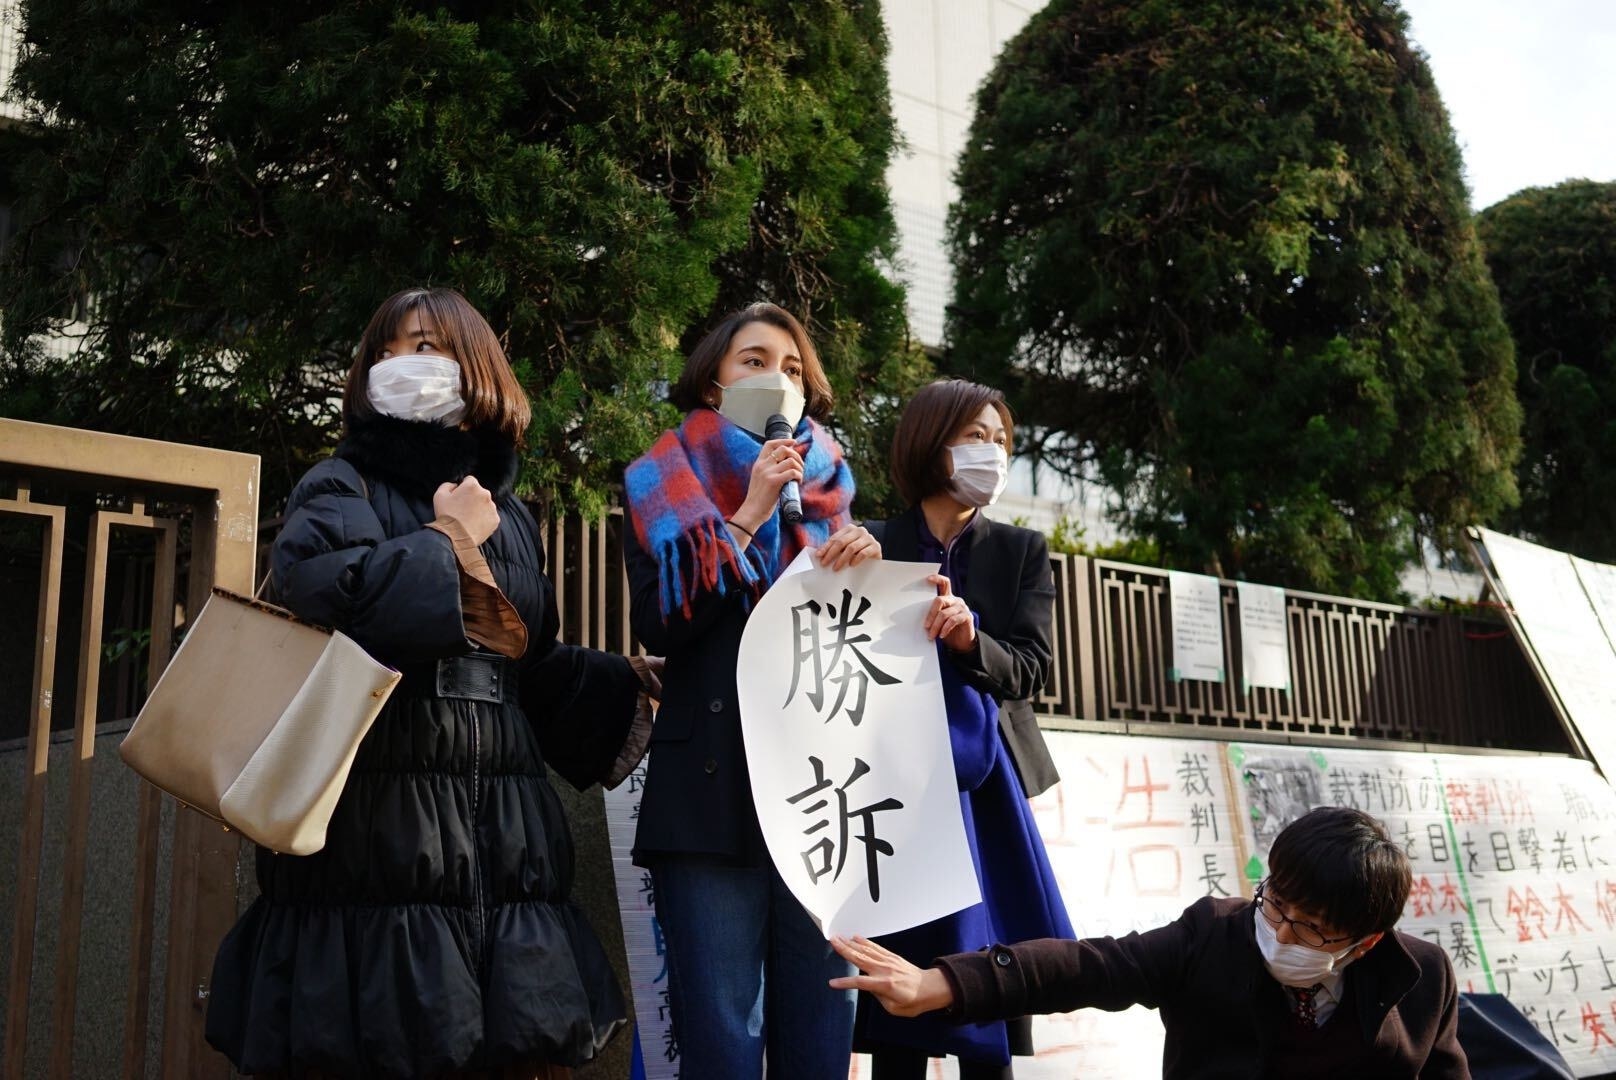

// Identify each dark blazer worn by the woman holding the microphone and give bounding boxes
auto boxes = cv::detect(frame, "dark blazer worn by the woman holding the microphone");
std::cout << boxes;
[622,511,764,865]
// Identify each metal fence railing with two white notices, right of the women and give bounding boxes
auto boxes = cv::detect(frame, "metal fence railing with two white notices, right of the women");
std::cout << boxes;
[1057,556,1569,752]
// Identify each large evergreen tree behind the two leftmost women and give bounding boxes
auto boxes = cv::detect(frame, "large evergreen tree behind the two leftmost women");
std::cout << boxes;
[0,0,911,508]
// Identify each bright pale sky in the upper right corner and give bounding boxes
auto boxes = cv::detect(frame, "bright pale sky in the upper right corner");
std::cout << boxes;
[1403,0,1616,210]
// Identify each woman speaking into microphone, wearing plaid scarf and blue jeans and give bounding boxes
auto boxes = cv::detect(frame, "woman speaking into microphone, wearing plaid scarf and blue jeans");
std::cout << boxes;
[624,304,879,1080]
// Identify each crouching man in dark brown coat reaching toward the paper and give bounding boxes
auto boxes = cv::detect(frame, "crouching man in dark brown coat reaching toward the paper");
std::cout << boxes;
[831,807,1471,1080]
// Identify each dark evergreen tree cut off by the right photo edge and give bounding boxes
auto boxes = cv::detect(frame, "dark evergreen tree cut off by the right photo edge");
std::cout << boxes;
[1477,179,1616,563]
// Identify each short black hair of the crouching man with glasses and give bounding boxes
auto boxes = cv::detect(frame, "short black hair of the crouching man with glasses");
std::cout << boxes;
[1269,807,1414,938]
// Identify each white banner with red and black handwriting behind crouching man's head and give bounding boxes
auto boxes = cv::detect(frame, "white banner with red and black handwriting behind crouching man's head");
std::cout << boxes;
[1221,743,1616,1077]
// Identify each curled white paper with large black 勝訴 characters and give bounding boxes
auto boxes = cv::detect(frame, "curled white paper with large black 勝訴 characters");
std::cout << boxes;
[737,556,981,936]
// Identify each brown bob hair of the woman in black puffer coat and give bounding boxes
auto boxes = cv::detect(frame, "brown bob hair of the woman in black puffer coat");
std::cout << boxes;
[343,288,533,446]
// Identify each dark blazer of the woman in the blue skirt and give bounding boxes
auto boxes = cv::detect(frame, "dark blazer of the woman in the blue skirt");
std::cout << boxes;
[865,506,1060,797]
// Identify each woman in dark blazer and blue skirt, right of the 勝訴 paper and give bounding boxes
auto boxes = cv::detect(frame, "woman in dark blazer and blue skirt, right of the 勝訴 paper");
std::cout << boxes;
[853,378,1071,1080]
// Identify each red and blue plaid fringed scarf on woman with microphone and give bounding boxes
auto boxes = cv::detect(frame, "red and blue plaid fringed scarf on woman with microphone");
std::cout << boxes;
[624,409,853,619]
